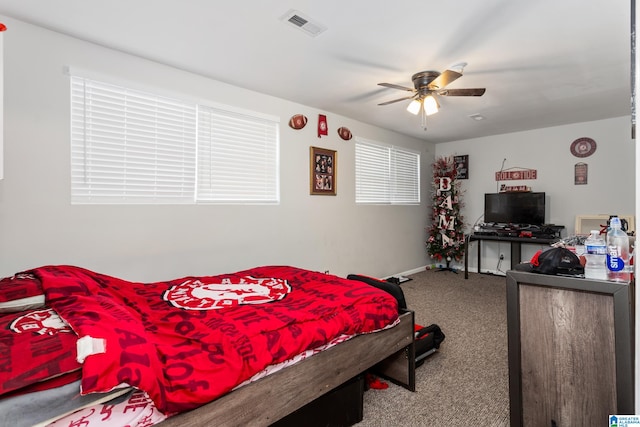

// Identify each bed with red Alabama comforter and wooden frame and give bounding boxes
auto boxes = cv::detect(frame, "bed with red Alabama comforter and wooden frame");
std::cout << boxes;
[0,266,415,427]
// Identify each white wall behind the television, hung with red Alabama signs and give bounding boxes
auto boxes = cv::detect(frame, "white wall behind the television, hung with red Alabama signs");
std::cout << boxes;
[436,116,636,273]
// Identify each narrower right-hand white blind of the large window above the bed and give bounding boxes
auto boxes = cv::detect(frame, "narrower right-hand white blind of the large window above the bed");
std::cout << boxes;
[196,106,280,203]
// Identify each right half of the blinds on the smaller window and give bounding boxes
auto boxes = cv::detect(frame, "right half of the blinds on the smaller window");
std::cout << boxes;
[391,147,420,204]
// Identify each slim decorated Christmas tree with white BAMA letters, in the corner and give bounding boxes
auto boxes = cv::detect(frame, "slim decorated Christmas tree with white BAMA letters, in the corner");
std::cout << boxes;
[427,157,465,270]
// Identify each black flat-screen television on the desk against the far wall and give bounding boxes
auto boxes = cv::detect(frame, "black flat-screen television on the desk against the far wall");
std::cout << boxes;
[484,192,545,225]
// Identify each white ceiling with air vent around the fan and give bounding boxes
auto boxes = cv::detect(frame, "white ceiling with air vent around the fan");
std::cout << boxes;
[0,0,631,142]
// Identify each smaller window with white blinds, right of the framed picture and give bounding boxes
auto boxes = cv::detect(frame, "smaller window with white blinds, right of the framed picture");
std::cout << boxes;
[355,139,420,205]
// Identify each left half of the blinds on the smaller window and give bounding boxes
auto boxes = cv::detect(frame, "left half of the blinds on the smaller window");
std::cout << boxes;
[355,141,391,203]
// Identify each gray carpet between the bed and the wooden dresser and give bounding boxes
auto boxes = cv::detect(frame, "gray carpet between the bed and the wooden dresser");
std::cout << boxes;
[357,270,509,427]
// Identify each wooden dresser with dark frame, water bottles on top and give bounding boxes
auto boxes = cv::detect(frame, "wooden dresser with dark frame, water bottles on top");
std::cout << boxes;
[507,271,634,427]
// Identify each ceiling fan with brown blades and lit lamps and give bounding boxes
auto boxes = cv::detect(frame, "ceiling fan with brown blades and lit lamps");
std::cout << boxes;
[378,64,486,130]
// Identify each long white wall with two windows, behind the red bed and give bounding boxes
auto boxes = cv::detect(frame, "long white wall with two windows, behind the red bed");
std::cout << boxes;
[0,17,435,280]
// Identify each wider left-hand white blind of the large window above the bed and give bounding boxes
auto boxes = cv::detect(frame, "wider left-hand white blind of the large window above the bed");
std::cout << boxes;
[71,76,196,203]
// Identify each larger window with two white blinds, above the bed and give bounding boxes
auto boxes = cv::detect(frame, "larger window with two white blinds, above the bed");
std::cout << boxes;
[71,76,279,204]
